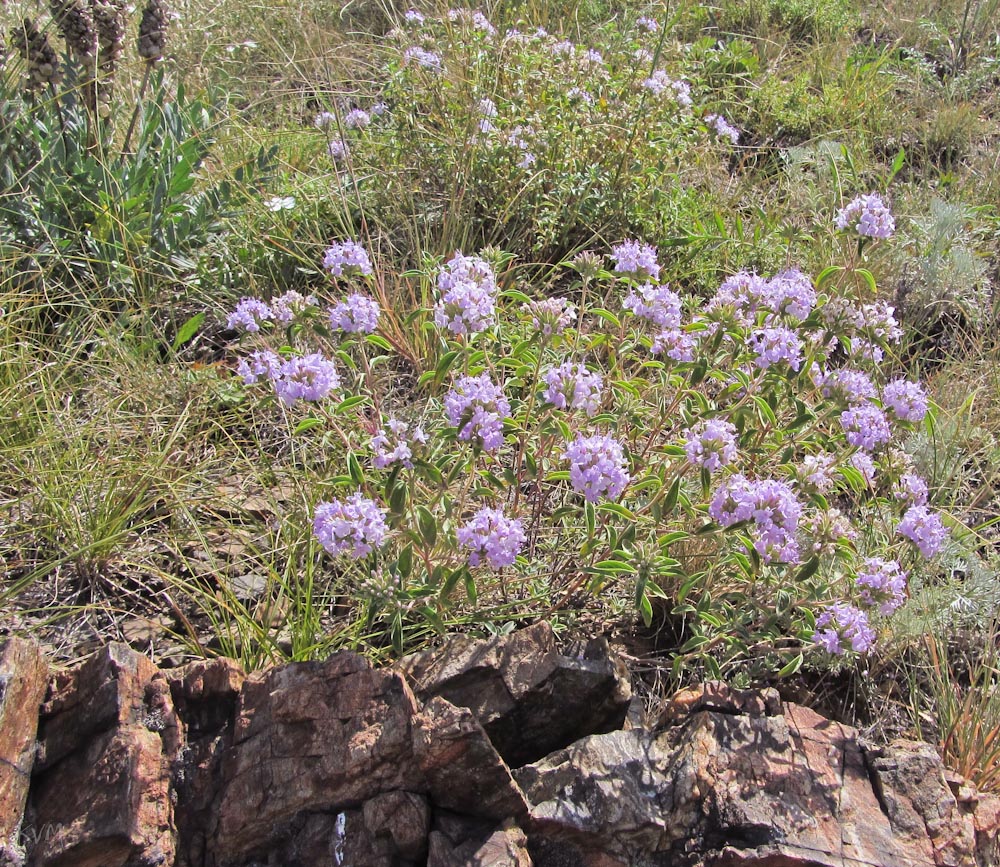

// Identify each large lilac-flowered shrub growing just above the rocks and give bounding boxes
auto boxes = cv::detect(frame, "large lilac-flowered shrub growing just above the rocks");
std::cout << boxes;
[223,219,948,671]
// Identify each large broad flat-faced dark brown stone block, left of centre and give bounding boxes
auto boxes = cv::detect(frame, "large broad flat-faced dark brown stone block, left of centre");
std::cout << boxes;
[209,653,423,864]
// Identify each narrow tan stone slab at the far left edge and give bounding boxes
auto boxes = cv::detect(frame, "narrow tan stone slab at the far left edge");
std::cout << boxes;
[0,638,48,861]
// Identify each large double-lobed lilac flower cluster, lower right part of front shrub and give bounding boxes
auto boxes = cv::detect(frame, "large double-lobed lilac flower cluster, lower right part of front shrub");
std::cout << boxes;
[708,474,802,563]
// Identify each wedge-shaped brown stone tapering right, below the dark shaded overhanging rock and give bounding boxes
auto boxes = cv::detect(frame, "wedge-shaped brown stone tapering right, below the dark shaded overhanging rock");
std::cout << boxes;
[413,698,528,821]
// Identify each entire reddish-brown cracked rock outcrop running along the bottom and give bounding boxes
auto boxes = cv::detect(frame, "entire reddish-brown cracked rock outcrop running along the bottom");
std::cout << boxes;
[0,625,1000,867]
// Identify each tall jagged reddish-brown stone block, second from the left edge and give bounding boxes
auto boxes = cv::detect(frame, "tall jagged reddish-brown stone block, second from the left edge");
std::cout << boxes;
[31,645,181,867]
